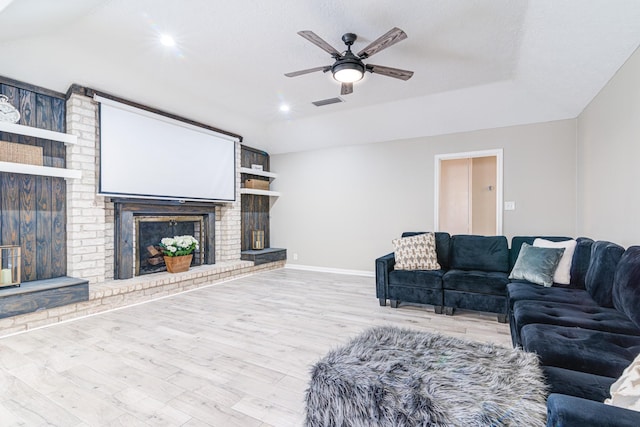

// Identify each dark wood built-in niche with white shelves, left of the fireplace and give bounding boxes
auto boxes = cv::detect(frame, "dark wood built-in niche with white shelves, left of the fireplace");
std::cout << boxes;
[0,77,89,318]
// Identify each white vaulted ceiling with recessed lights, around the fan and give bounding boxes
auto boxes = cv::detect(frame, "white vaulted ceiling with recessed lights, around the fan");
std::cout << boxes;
[0,0,640,153]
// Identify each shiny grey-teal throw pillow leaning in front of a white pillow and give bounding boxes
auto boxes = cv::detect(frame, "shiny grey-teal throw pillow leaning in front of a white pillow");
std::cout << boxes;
[509,243,564,287]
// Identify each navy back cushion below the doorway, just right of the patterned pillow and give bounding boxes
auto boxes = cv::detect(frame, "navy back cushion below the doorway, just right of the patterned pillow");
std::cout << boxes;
[450,234,509,273]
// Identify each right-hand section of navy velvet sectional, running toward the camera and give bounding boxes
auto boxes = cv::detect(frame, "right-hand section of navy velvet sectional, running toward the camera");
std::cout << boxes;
[507,246,640,426]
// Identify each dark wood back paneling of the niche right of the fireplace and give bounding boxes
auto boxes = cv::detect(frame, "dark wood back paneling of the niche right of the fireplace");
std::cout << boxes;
[240,145,271,251]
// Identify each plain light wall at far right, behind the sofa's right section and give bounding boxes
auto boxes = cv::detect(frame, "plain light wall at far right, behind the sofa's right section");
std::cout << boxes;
[578,45,640,247]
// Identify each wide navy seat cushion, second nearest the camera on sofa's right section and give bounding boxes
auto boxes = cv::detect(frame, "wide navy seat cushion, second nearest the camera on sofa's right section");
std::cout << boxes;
[520,324,640,378]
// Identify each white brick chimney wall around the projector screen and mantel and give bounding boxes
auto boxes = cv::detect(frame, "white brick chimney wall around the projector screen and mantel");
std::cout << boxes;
[67,86,241,284]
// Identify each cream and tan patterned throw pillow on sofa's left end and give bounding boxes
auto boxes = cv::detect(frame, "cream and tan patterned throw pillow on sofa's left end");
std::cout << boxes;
[393,233,440,270]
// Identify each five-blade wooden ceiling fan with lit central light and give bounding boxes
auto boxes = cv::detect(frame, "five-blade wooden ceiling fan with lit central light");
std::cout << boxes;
[285,28,413,95]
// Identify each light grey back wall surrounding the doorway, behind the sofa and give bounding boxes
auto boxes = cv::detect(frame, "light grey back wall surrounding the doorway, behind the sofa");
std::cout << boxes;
[271,120,576,271]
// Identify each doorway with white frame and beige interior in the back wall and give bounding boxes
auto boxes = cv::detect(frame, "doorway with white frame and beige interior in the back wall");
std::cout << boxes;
[434,149,502,236]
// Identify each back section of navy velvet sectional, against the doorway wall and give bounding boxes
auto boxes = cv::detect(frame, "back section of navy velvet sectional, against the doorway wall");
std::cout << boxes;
[376,232,593,323]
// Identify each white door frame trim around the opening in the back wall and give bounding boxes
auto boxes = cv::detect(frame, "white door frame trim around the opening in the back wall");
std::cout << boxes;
[433,148,503,236]
